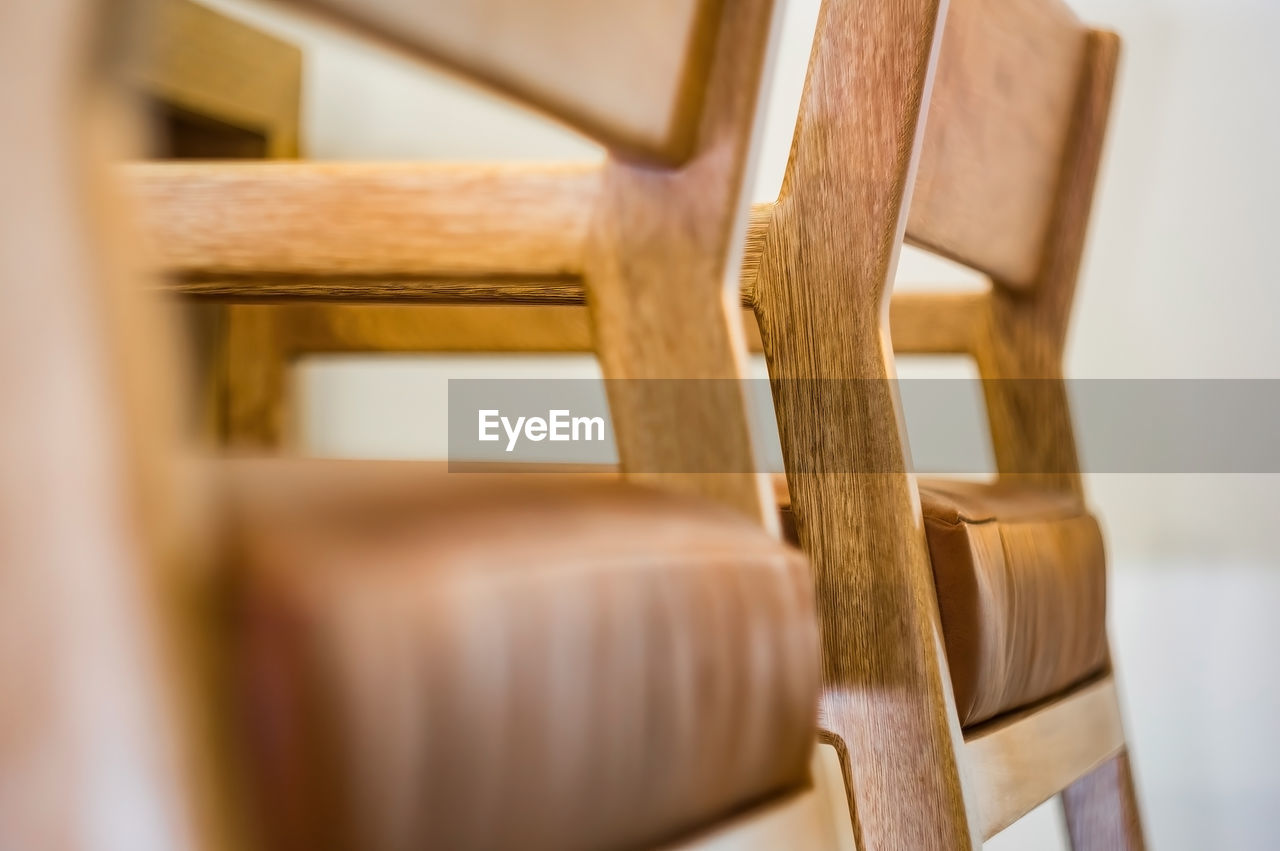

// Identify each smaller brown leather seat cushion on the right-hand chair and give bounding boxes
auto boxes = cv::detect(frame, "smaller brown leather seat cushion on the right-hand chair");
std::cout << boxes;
[778,479,1107,726]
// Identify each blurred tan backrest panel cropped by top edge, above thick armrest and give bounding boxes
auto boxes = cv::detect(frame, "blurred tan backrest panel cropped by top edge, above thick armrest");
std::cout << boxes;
[288,0,723,161]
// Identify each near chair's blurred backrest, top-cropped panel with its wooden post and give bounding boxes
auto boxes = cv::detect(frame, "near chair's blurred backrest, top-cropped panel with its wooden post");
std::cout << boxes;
[281,0,777,530]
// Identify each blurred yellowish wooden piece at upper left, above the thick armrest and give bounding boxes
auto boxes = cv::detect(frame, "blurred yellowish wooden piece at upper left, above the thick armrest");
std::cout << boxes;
[128,0,302,157]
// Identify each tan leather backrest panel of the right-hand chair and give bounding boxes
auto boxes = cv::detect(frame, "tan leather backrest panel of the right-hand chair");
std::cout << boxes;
[908,0,1085,288]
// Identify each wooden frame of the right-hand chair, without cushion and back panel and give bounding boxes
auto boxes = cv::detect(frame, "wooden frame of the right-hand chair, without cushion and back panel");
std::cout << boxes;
[755,0,1143,848]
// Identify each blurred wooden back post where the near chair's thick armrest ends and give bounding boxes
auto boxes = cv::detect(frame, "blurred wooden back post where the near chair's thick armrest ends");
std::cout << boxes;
[584,0,778,531]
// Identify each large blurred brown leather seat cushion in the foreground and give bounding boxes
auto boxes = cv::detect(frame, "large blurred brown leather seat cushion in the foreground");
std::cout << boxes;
[220,462,819,850]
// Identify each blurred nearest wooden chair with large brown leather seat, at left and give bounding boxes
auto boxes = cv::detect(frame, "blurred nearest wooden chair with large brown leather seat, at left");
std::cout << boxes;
[0,0,847,848]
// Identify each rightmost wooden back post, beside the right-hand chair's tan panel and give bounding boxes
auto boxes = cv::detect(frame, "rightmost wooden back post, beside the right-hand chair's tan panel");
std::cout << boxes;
[974,32,1120,493]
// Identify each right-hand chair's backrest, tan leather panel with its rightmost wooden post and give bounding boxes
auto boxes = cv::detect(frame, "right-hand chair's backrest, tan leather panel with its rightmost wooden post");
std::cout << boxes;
[906,0,1120,493]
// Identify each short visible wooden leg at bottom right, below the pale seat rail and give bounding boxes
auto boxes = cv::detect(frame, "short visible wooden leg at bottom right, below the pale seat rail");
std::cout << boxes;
[1062,750,1147,851]
